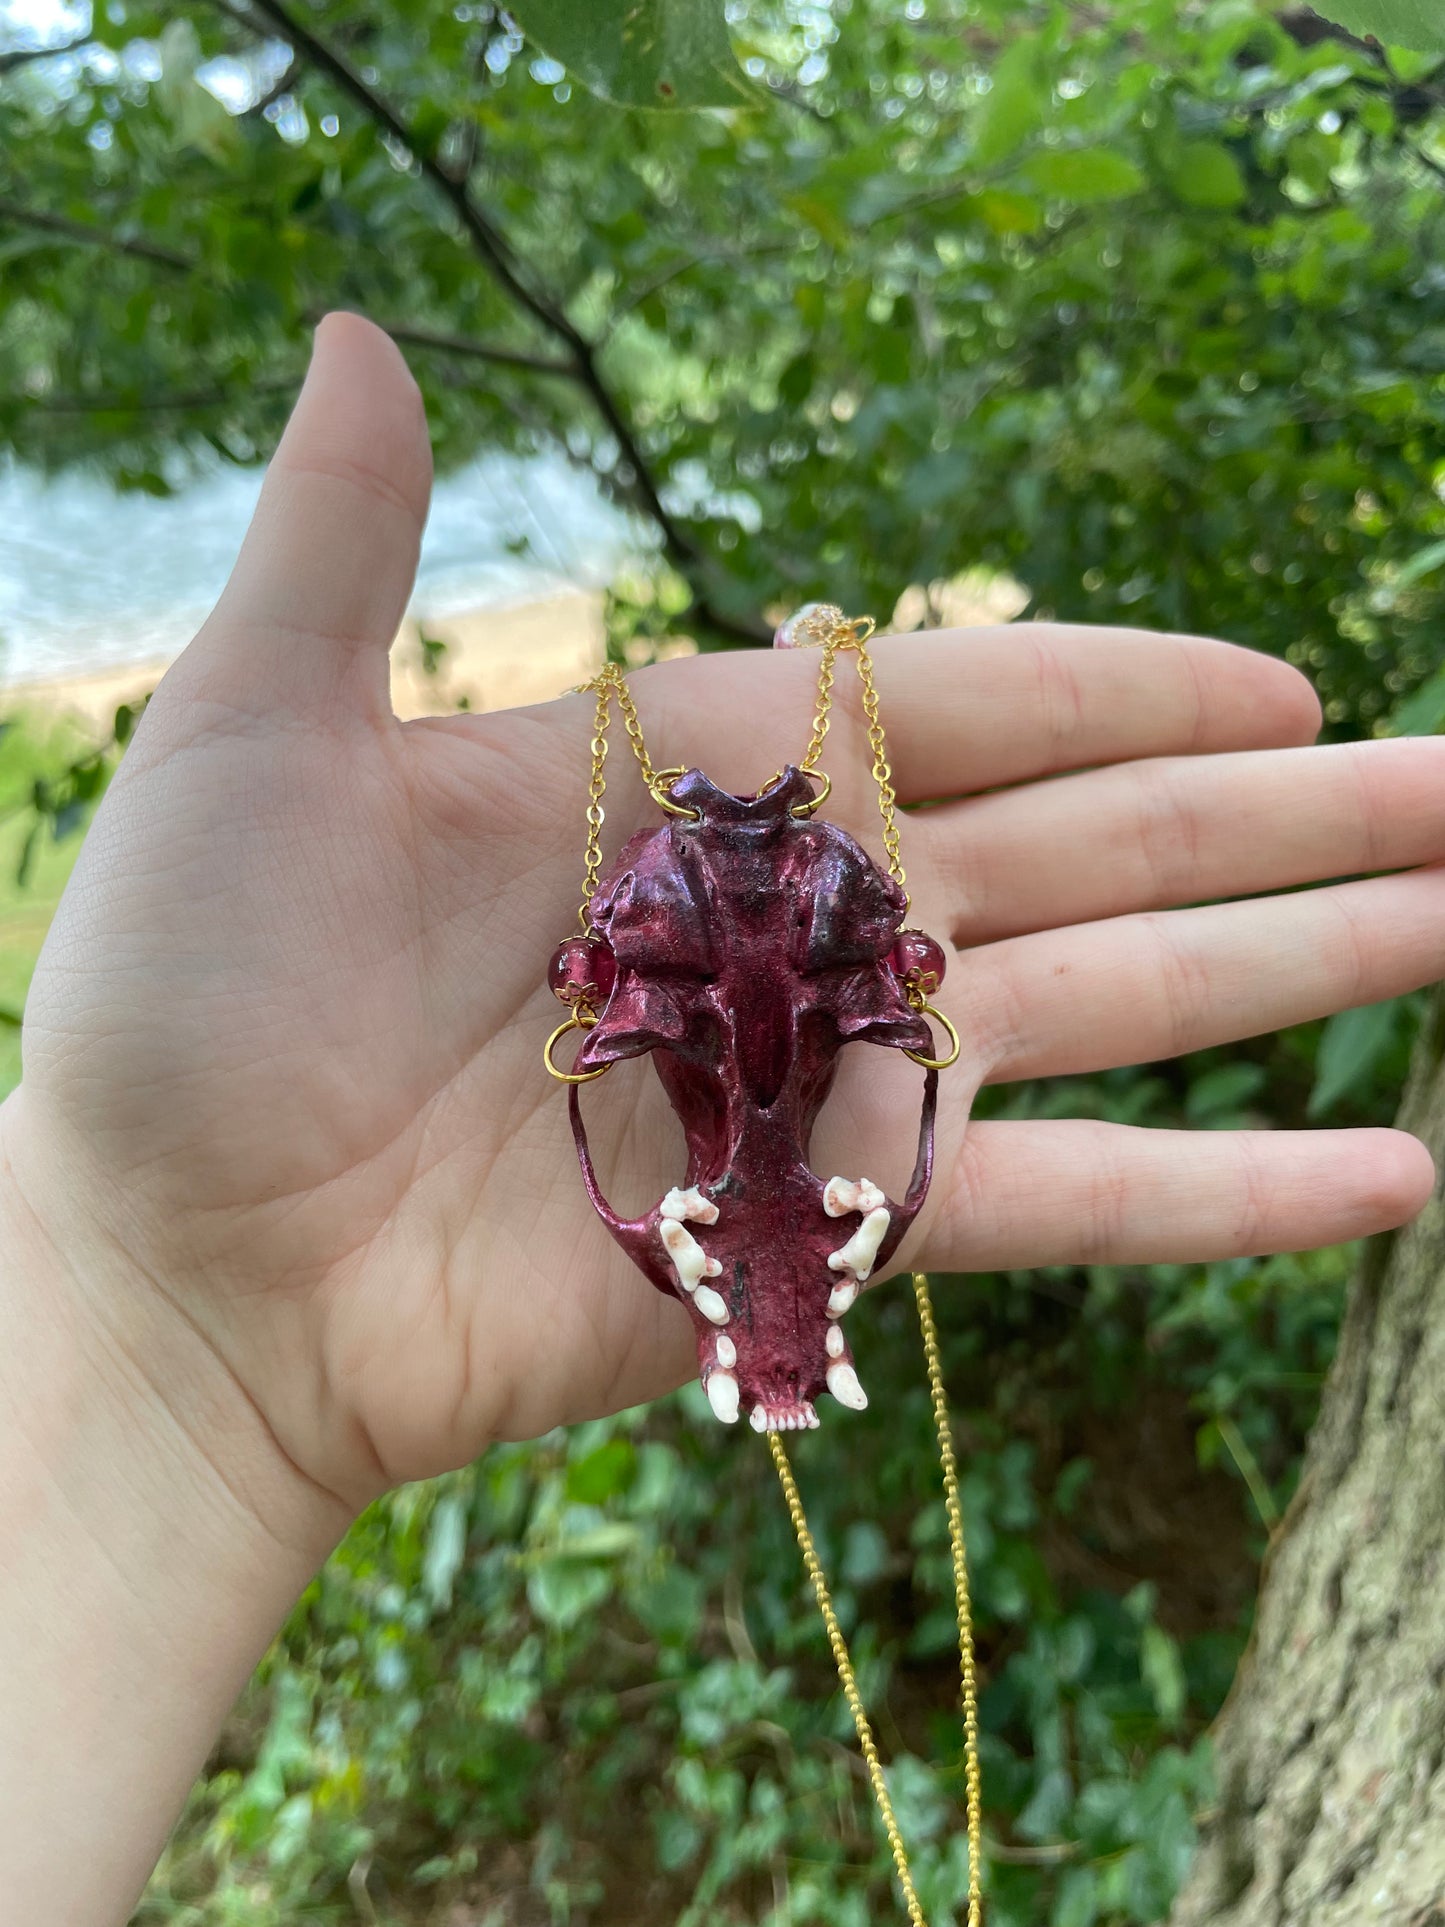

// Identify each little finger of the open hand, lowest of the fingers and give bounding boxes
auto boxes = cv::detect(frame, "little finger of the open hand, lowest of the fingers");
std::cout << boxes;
[915,1120,1433,1272]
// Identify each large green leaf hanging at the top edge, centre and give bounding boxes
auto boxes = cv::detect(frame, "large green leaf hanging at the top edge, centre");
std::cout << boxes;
[509,0,759,108]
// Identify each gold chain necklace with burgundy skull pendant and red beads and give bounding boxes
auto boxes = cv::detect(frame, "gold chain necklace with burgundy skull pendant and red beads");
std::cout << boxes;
[543,603,983,1927]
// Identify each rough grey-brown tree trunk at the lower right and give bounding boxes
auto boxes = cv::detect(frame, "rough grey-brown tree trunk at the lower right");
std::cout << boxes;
[1171,996,1445,1927]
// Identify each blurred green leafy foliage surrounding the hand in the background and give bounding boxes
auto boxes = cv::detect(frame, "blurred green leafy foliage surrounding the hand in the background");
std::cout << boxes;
[0,0,1445,1927]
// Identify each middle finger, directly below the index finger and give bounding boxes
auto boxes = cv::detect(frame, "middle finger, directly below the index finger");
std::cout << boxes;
[909,736,1445,946]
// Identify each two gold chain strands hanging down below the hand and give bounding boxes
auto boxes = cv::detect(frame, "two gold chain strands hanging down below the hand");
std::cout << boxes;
[767,1272,983,1927]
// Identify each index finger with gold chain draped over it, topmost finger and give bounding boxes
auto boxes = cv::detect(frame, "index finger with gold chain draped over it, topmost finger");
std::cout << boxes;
[634,622,1320,802]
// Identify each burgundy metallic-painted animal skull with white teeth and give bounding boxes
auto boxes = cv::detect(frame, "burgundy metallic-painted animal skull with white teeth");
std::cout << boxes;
[559,767,942,1432]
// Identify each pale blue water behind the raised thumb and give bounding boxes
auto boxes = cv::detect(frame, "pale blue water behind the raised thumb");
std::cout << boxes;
[0,455,630,684]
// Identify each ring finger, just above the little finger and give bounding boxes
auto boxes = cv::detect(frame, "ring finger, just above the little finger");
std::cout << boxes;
[963,867,1445,1083]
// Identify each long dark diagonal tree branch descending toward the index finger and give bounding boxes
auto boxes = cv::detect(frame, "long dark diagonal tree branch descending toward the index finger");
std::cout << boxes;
[212,0,767,642]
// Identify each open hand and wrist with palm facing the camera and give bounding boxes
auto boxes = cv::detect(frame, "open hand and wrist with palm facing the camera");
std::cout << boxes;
[0,316,1445,1927]
